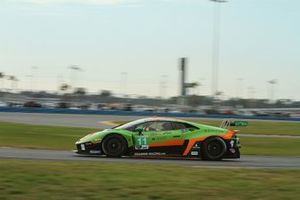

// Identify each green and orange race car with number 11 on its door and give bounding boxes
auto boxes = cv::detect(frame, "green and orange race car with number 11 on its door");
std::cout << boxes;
[75,117,248,160]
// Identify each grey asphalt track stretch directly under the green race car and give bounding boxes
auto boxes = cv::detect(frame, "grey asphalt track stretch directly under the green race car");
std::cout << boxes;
[0,148,300,169]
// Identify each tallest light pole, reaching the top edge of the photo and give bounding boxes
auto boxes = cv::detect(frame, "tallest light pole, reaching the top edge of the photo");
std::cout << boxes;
[210,0,227,98]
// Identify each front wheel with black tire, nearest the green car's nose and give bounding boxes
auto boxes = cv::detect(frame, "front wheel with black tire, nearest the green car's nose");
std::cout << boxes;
[102,135,127,157]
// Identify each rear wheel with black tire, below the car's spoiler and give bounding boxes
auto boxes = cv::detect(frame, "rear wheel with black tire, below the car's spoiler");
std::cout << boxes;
[201,137,227,160]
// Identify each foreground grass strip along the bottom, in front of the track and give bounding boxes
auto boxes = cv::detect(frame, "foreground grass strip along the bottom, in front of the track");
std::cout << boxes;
[0,160,300,200]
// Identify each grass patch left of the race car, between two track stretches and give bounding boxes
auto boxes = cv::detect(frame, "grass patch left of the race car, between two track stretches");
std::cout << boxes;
[0,122,97,150]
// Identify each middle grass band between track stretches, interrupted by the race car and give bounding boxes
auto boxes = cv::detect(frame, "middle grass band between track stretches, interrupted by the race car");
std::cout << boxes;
[0,122,300,156]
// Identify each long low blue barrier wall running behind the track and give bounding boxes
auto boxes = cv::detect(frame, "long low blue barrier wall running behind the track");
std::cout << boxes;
[0,107,300,121]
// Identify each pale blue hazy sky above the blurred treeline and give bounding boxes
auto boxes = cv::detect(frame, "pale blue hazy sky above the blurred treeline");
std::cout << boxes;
[0,0,300,100]
